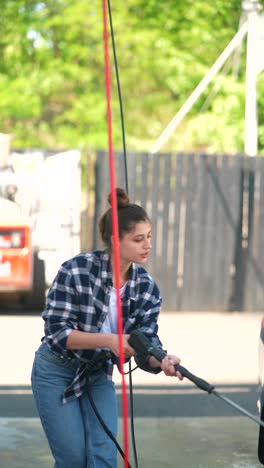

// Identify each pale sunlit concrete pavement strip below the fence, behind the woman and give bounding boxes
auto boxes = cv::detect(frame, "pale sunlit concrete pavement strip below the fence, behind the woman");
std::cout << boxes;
[0,312,264,385]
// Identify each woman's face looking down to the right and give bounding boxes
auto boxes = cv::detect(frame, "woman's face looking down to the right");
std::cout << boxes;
[119,222,151,264]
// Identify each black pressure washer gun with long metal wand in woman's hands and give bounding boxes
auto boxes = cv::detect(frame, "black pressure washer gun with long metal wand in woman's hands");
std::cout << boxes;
[128,330,264,427]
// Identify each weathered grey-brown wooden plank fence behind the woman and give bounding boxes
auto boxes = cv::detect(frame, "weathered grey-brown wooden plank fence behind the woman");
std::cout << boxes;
[93,152,264,311]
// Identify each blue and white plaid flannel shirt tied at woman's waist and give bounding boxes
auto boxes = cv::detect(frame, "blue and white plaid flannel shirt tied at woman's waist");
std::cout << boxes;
[42,250,162,403]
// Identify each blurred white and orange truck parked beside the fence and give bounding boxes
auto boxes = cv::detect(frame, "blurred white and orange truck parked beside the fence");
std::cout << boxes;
[0,150,82,309]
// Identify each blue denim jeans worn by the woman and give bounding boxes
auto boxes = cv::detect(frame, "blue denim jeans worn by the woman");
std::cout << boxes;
[32,343,118,468]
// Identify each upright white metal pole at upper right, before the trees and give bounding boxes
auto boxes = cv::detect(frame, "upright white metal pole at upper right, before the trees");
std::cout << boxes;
[242,0,261,156]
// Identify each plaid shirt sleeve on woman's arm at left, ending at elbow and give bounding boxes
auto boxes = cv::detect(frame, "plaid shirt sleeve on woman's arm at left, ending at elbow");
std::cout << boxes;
[42,264,79,355]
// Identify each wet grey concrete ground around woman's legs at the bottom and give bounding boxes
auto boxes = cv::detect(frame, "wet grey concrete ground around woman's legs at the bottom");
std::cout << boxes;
[0,417,261,468]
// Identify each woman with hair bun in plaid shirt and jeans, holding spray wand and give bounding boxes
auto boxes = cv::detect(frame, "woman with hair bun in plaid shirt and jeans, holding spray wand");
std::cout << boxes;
[32,189,182,468]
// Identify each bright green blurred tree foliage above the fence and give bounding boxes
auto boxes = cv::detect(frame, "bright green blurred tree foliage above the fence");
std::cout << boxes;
[0,0,264,153]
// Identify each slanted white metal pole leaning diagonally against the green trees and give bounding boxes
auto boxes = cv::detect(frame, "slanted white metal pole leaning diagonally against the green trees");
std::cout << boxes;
[151,21,248,154]
